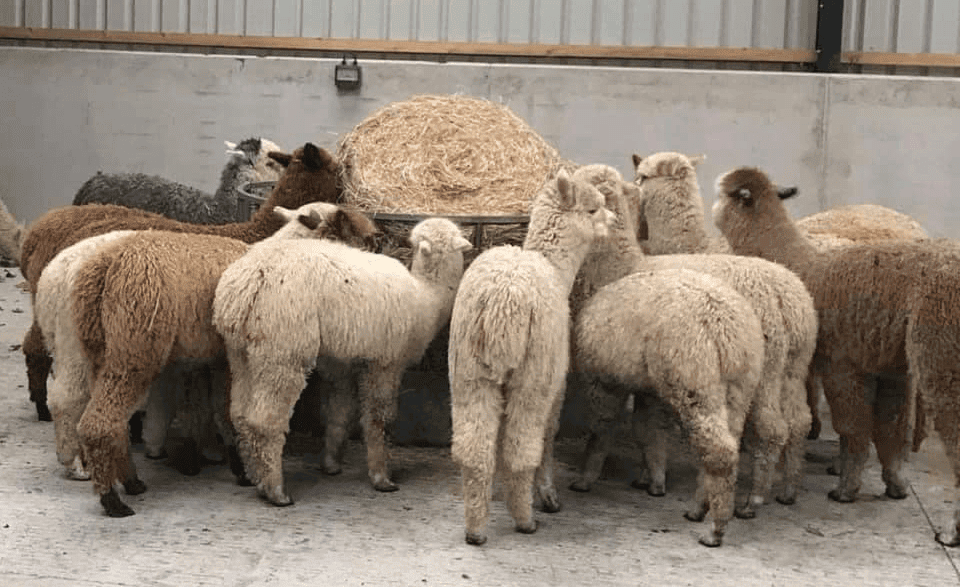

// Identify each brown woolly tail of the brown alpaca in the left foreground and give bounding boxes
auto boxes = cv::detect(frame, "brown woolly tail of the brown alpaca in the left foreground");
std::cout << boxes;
[71,255,112,369]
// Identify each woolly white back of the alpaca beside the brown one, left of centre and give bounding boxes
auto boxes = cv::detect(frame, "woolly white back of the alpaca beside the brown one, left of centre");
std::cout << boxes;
[214,240,445,362]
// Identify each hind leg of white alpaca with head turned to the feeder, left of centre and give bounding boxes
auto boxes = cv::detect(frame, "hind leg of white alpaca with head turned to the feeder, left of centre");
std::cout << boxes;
[230,352,306,506]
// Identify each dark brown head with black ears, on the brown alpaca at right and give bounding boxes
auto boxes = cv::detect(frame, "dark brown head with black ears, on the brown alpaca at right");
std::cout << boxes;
[713,167,797,240]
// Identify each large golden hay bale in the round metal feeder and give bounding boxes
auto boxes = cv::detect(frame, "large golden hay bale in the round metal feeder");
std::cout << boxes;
[337,95,571,215]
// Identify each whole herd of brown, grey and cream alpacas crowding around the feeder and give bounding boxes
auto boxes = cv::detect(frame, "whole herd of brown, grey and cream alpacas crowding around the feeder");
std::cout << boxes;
[0,139,960,546]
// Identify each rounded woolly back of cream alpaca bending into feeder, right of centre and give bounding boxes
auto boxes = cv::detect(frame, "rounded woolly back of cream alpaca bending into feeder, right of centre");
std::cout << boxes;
[576,270,763,393]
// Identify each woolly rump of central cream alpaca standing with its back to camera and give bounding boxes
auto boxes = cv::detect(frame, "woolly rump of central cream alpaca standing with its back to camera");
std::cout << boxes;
[449,246,569,382]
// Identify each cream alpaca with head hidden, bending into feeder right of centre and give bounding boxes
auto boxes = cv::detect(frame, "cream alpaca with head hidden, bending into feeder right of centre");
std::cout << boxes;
[574,269,763,546]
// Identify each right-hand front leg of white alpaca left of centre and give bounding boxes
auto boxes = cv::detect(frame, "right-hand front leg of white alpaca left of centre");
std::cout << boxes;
[359,364,403,492]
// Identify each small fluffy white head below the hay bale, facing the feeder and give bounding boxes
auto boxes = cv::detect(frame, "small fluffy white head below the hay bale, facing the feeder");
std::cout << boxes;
[410,218,473,285]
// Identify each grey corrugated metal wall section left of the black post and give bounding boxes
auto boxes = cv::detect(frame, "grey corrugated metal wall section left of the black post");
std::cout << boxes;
[0,0,817,49]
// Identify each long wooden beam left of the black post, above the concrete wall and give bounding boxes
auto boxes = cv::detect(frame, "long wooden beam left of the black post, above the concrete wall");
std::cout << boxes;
[0,27,816,63]
